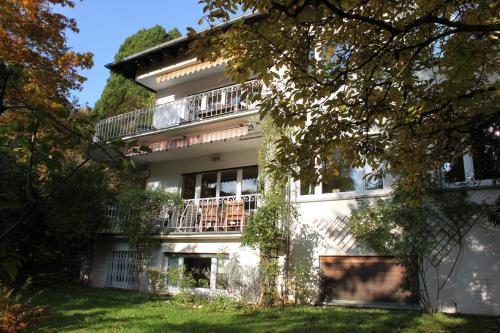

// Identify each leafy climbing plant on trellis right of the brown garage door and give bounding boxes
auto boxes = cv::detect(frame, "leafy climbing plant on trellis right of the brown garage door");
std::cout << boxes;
[348,191,489,312]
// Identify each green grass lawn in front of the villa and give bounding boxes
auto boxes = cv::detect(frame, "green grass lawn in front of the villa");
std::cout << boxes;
[26,285,500,333]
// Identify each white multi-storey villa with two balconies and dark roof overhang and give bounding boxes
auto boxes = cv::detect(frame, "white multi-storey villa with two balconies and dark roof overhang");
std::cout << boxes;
[90,19,500,315]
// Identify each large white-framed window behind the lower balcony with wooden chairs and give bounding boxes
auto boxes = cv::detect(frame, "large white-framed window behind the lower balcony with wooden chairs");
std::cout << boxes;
[181,165,258,199]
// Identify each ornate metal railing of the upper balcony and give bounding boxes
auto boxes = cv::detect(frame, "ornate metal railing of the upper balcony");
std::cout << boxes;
[96,81,257,142]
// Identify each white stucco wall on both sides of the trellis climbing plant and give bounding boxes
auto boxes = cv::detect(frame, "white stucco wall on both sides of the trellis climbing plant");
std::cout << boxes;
[291,185,500,315]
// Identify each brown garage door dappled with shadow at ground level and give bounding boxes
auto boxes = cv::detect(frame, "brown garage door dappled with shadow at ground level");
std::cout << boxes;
[320,256,418,304]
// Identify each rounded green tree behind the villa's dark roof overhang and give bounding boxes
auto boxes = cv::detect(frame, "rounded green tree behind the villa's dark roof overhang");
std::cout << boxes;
[95,25,181,118]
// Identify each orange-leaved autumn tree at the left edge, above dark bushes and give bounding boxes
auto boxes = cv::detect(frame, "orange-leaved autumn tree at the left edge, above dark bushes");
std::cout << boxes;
[0,0,93,240]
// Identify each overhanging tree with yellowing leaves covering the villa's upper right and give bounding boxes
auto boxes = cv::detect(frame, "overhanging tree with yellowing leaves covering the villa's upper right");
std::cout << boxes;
[190,0,500,197]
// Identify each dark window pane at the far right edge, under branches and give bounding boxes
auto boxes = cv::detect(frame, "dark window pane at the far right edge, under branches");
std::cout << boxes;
[472,128,500,180]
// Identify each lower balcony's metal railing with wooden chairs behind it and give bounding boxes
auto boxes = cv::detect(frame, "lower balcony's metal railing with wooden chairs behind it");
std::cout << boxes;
[102,194,259,234]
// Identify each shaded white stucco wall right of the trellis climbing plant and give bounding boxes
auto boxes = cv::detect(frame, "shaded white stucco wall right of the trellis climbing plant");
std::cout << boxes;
[427,189,500,316]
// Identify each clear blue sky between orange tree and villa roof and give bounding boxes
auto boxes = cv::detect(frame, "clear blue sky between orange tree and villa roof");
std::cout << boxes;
[58,0,211,107]
